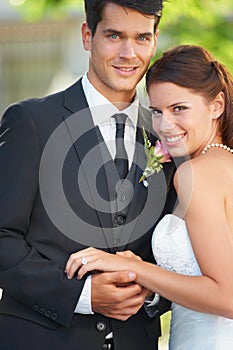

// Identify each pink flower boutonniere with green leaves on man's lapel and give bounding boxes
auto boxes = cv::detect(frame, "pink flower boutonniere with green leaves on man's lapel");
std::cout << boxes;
[139,127,171,187]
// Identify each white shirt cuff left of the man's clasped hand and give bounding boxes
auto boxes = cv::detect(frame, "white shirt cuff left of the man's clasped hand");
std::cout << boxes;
[74,275,94,315]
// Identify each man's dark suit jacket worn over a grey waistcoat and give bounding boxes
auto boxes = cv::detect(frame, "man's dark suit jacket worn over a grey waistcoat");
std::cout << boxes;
[0,81,175,350]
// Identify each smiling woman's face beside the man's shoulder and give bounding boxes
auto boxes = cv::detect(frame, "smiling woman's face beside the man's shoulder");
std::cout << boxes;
[149,82,219,157]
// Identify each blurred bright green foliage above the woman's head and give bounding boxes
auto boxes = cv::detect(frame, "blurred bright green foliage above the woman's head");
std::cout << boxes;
[157,0,233,71]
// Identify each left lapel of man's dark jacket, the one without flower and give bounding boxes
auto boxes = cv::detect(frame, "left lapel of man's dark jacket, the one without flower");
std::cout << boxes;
[63,81,113,247]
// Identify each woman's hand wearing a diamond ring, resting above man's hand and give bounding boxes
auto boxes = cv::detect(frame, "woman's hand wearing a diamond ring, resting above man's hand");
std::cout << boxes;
[65,248,135,279]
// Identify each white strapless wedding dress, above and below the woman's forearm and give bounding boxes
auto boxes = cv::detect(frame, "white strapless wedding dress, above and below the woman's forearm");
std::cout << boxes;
[152,214,233,350]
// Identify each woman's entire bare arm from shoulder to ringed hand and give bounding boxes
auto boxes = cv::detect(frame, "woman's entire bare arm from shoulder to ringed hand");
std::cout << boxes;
[66,159,233,318]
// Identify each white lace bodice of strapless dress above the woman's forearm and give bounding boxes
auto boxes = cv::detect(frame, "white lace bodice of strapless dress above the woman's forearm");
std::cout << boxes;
[152,214,201,276]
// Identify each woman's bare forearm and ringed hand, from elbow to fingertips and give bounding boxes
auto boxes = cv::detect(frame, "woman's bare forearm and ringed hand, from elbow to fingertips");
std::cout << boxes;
[66,248,233,318]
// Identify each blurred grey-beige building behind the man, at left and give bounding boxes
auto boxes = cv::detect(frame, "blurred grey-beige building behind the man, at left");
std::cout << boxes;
[0,0,88,115]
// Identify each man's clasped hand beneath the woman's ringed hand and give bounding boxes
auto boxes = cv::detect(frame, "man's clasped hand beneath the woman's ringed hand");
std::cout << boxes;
[91,271,148,321]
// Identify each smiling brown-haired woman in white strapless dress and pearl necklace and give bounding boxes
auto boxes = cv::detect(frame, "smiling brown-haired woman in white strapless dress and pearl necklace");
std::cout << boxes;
[66,45,233,350]
